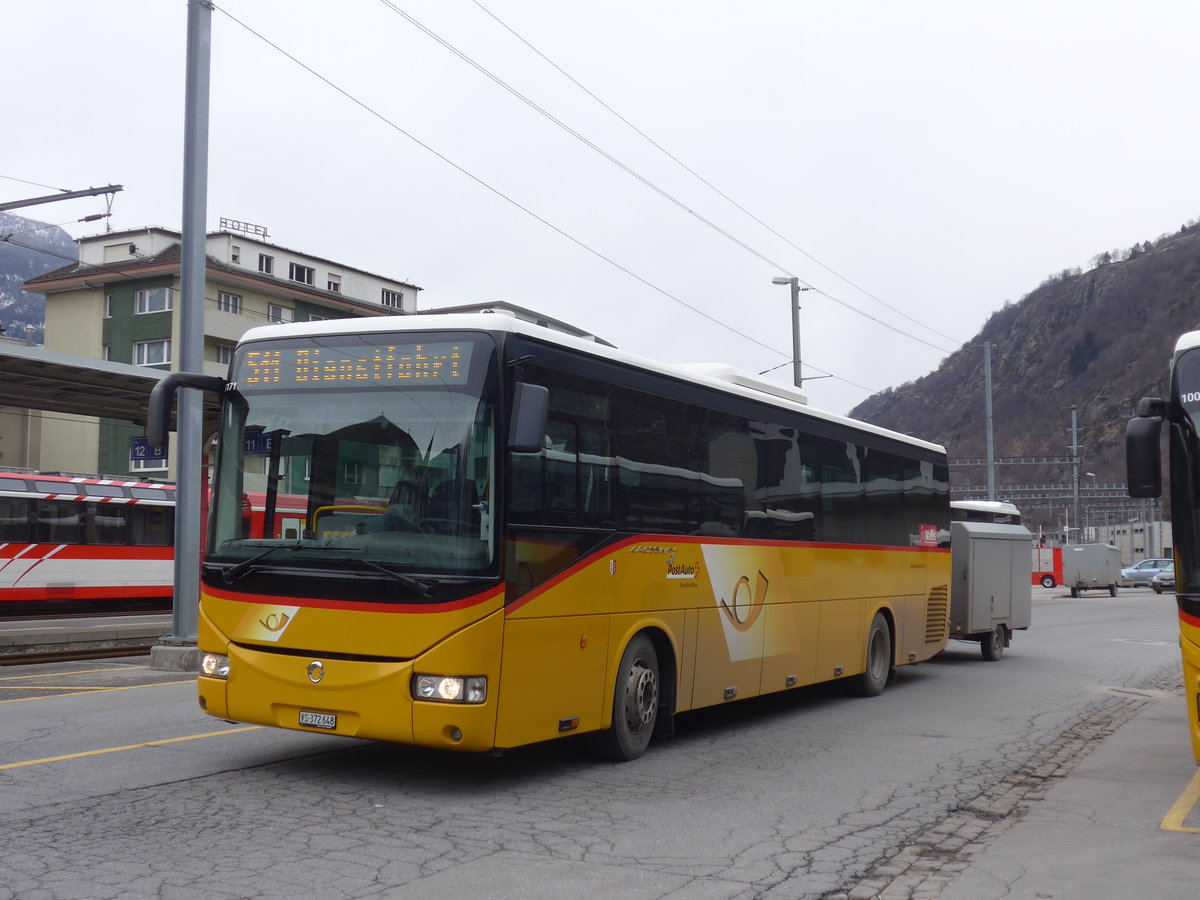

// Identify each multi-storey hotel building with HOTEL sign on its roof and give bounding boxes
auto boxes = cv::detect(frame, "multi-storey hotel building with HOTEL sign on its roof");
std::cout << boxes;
[17,220,421,478]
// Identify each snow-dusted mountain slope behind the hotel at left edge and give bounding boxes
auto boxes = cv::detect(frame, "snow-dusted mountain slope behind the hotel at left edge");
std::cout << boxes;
[0,212,78,343]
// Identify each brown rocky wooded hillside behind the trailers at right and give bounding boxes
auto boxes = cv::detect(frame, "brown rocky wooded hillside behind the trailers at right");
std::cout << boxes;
[851,224,1200,528]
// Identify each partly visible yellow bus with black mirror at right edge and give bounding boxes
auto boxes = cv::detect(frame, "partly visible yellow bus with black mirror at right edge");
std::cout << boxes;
[1126,331,1200,763]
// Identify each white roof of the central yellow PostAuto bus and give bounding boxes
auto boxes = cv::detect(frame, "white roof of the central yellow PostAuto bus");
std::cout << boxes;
[240,310,946,454]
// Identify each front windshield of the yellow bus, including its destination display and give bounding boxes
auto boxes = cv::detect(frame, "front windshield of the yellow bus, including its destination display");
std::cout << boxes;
[206,334,497,580]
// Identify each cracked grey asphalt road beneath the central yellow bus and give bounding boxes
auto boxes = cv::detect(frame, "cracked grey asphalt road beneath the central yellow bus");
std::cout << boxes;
[0,588,1190,900]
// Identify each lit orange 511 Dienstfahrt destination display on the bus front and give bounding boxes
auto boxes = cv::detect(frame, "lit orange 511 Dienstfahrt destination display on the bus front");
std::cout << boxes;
[238,342,472,388]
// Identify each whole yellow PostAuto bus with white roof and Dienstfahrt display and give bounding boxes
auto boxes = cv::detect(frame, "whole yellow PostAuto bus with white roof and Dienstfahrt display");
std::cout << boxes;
[151,313,950,760]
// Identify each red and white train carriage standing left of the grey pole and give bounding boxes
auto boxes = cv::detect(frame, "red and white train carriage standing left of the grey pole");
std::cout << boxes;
[0,472,175,614]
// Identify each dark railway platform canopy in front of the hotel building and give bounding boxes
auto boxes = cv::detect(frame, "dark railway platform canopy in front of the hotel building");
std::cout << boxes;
[0,342,218,431]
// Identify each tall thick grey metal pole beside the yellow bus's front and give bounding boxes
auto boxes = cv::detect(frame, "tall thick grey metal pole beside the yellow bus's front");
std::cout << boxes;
[164,0,212,643]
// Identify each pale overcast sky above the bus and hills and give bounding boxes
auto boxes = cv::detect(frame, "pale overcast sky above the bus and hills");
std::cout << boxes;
[9,0,1200,415]
